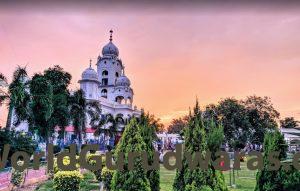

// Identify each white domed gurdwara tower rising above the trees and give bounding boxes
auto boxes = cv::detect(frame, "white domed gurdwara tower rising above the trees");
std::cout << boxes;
[79,31,141,123]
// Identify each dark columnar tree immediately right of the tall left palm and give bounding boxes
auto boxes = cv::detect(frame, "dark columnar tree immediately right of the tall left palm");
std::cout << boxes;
[29,74,54,144]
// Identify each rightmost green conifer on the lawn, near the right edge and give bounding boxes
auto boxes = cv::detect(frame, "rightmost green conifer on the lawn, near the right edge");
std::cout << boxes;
[255,131,290,191]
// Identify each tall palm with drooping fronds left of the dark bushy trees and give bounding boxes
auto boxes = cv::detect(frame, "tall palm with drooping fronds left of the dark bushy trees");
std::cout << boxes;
[6,66,30,130]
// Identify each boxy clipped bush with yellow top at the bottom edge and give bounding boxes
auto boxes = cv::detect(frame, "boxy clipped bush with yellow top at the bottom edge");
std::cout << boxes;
[53,171,83,191]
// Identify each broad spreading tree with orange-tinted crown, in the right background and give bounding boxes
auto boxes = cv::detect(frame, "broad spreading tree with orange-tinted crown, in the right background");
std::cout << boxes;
[203,95,279,149]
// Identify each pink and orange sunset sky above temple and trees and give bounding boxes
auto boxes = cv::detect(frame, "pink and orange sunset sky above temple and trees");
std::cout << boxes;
[0,4,300,125]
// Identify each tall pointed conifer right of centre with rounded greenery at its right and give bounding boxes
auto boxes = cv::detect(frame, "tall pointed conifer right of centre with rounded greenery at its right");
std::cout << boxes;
[173,101,227,191]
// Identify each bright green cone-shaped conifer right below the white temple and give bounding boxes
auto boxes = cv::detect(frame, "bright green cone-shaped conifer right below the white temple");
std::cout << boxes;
[111,118,150,191]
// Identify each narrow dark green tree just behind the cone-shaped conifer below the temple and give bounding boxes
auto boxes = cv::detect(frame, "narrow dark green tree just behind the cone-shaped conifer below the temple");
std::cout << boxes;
[139,112,160,191]
